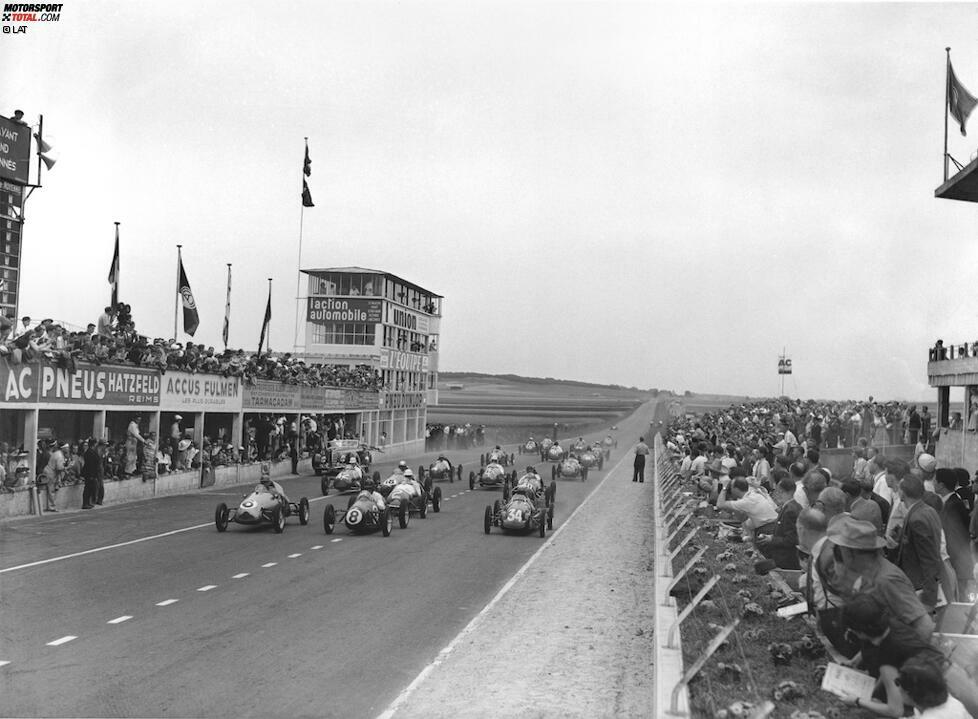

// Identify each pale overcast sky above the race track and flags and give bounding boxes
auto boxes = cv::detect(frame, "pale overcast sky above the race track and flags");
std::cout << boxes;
[0,0,978,399]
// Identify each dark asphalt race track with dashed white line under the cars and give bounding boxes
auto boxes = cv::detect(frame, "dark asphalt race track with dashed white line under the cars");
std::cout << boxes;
[0,409,648,717]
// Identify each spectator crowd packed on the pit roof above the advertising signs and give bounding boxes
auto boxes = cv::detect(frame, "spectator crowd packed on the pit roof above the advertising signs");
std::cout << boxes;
[0,302,382,390]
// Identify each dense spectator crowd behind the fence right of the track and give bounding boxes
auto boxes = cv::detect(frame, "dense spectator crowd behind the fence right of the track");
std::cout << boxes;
[664,398,978,719]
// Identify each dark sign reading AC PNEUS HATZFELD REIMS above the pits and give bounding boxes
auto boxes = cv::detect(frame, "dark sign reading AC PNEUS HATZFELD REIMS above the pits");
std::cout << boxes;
[0,361,160,407]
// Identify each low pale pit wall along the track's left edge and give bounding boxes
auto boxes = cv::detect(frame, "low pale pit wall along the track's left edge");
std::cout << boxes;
[0,459,312,520]
